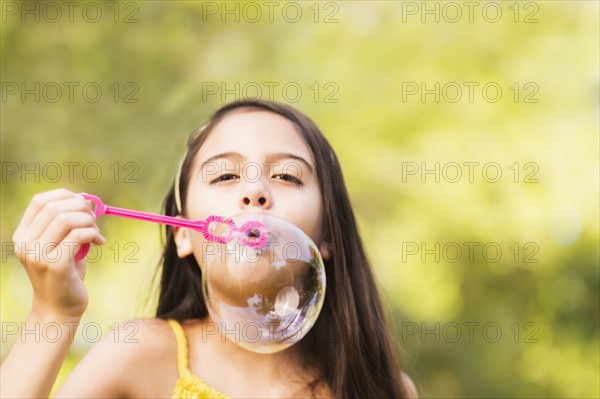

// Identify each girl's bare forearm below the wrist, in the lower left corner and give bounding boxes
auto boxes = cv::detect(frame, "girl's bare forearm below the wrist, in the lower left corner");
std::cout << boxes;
[0,312,79,398]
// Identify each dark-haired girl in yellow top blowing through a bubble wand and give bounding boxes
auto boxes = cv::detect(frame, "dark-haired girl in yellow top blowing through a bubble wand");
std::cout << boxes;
[1,100,416,399]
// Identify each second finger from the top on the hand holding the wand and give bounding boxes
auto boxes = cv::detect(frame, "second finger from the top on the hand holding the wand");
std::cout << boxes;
[19,198,94,240]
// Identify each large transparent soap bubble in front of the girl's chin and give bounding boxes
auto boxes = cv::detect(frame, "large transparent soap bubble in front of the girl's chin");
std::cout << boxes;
[201,213,325,353]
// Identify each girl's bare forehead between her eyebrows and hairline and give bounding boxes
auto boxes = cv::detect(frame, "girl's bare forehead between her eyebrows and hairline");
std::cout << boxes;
[198,110,314,163]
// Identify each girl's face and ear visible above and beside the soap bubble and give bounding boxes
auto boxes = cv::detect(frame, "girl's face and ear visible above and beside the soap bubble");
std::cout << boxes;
[175,110,323,259]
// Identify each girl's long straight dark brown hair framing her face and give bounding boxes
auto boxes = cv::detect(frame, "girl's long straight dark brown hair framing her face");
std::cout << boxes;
[156,100,410,399]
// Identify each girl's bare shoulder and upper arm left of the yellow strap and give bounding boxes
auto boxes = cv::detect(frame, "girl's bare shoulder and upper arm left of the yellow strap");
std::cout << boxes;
[55,319,178,398]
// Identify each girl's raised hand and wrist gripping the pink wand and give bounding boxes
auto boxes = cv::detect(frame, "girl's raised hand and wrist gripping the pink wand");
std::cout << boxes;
[13,189,106,320]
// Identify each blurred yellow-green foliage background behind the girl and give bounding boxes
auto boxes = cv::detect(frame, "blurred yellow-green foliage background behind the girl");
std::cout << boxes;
[0,1,600,398]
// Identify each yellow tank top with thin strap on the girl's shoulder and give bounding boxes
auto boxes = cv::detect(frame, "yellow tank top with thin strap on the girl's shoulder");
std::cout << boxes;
[168,320,227,399]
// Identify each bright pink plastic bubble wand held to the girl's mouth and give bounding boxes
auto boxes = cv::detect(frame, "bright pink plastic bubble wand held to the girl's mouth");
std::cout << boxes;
[75,193,269,260]
